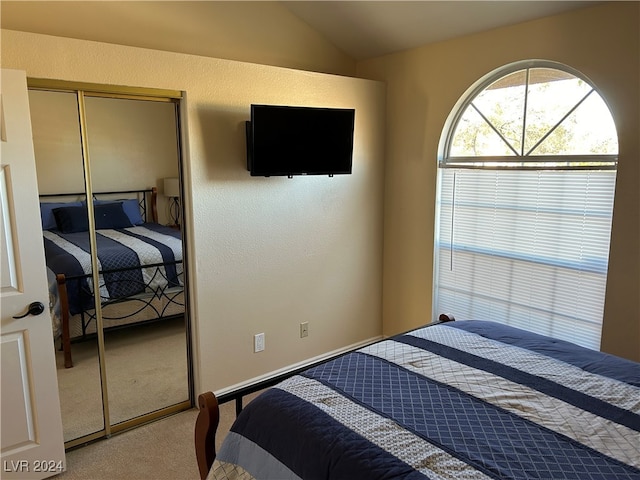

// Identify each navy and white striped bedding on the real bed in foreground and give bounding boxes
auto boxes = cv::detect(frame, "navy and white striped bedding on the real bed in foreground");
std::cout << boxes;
[209,321,640,480]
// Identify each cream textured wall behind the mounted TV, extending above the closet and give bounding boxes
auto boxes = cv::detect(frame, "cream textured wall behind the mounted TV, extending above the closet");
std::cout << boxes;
[2,30,385,392]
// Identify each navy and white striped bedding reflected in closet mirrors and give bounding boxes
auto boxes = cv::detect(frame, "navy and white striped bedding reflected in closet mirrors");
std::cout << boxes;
[43,223,182,315]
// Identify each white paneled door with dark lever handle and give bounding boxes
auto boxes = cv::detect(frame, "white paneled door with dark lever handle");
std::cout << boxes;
[0,69,65,479]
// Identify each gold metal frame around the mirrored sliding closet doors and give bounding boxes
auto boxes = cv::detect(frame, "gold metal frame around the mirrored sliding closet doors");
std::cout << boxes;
[27,78,195,449]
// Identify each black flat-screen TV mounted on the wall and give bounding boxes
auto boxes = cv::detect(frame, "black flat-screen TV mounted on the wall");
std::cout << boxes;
[247,105,355,177]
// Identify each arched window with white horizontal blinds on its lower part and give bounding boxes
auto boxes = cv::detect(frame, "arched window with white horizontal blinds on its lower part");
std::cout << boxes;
[434,61,618,349]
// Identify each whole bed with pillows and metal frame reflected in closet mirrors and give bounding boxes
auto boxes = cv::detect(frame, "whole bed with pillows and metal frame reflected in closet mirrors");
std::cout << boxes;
[40,187,184,368]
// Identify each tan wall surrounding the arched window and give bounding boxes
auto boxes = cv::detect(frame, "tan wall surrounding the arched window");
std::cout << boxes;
[358,2,640,360]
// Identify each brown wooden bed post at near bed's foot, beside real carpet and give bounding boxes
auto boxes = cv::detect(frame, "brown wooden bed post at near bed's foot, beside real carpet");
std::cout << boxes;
[195,392,220,480]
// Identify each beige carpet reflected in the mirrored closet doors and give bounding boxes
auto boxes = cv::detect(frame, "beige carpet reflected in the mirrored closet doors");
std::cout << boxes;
[56,318,189,441]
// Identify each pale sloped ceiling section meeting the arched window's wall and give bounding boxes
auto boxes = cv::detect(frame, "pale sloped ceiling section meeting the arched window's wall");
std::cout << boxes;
[282,0,598,60]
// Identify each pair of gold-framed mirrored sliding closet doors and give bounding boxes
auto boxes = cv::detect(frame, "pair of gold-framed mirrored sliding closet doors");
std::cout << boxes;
[30,80,193,447]
